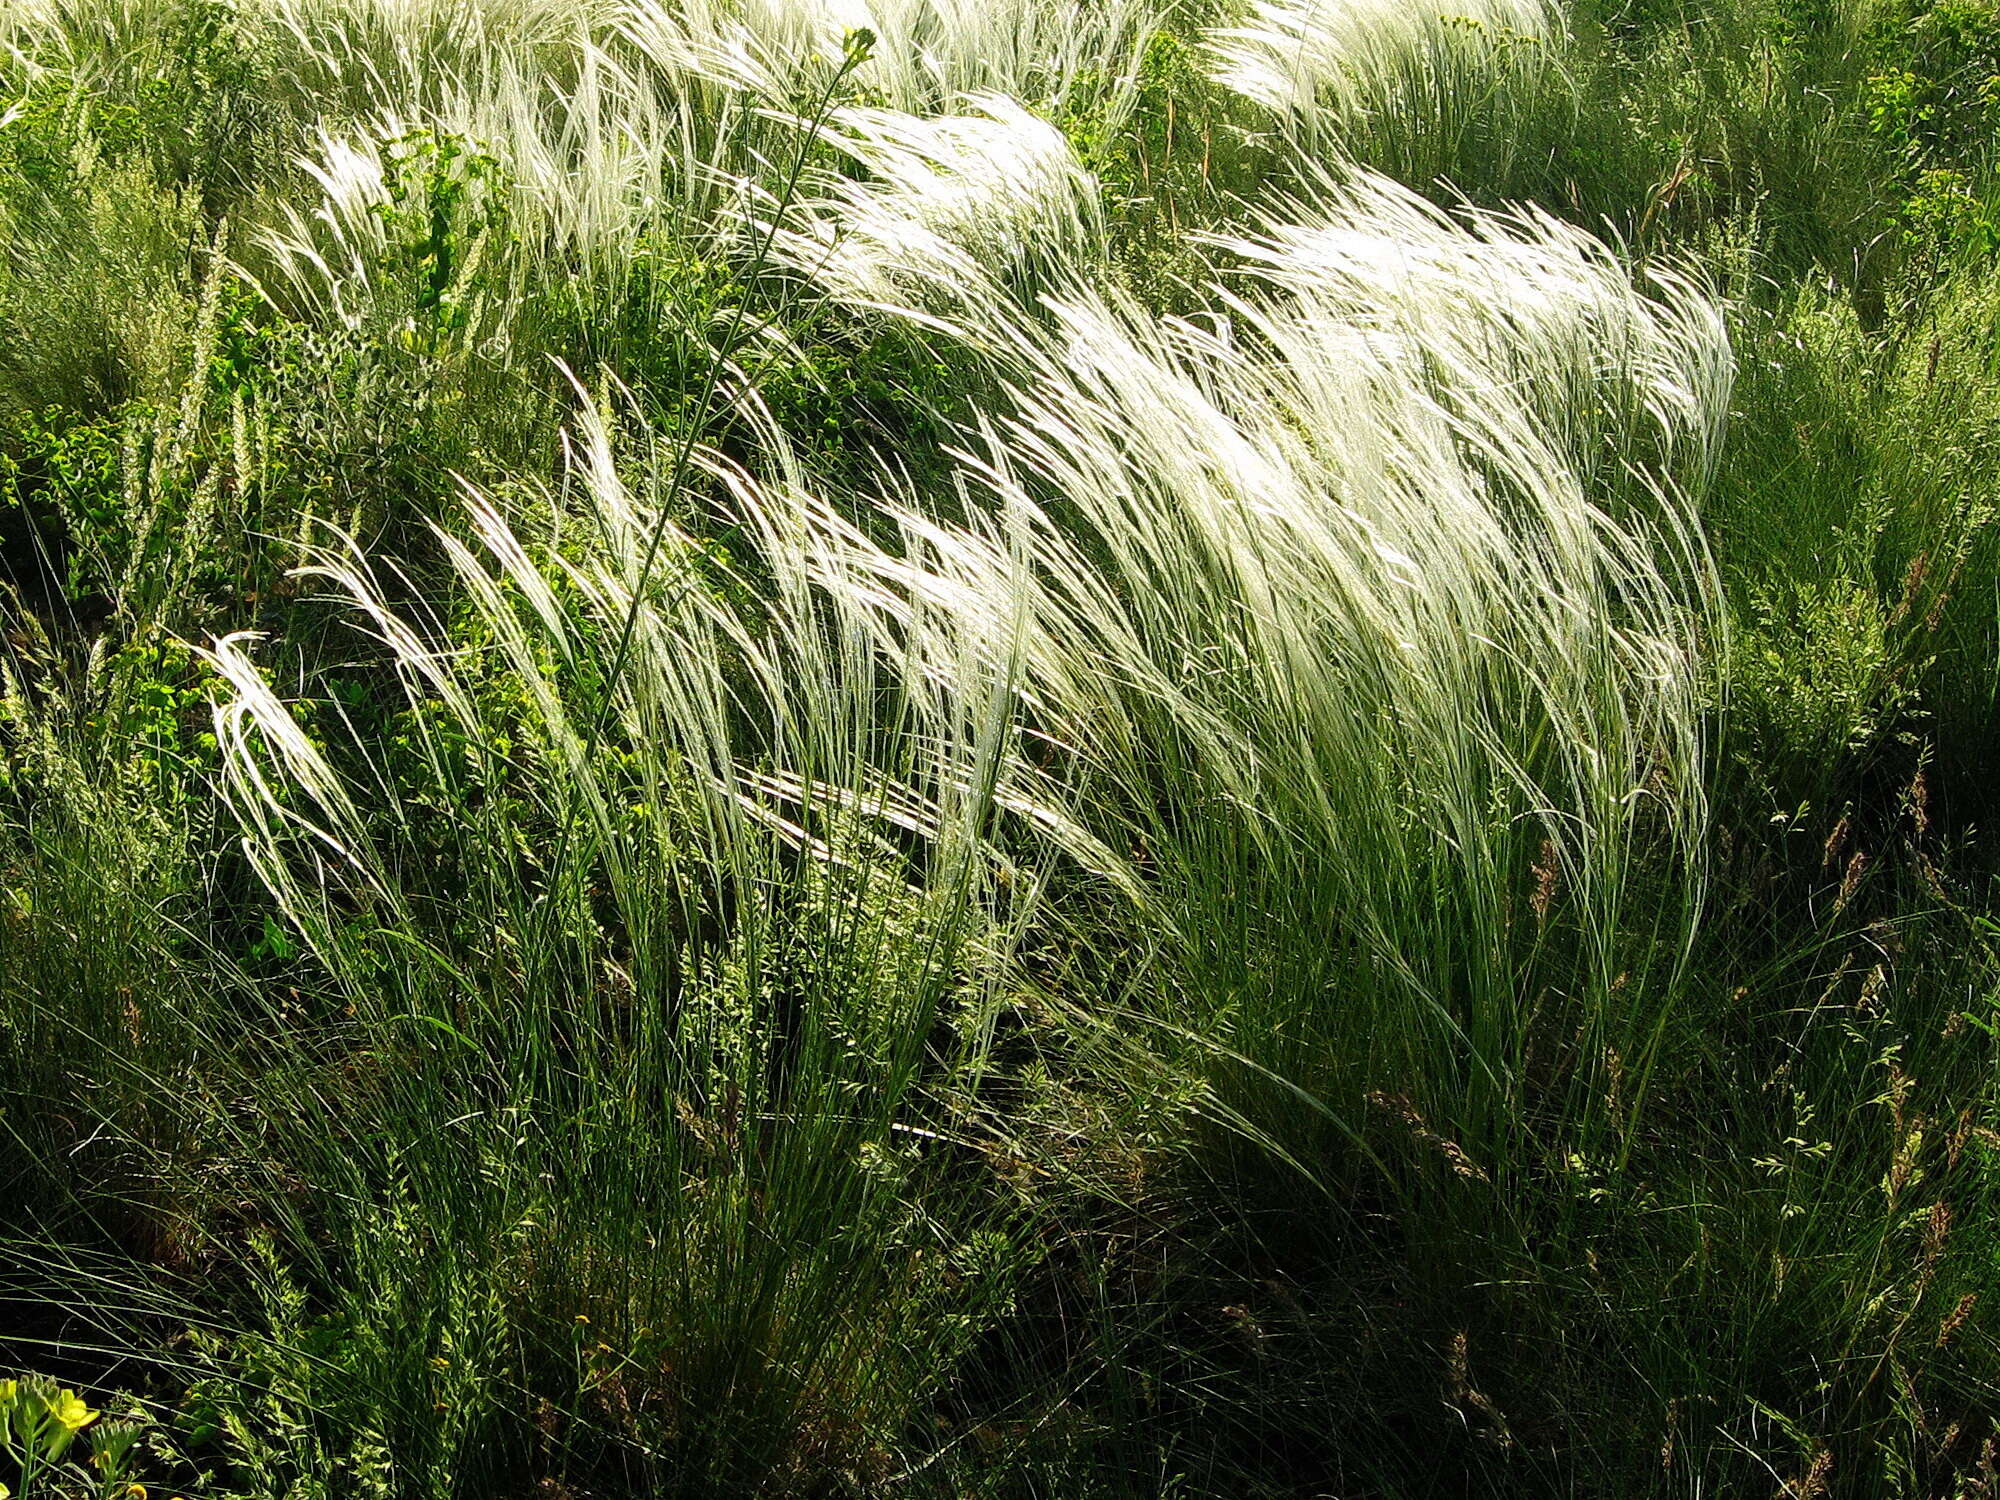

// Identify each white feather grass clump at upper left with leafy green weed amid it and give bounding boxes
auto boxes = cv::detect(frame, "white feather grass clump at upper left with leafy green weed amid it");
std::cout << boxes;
[244,7,884,412]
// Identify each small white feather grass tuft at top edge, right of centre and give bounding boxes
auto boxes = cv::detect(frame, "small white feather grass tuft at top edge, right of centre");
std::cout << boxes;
[1206,0,1562,184]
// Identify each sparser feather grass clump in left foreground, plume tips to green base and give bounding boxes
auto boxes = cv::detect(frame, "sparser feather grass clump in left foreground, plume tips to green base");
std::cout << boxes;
[199,390,1048,1484]
